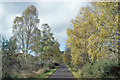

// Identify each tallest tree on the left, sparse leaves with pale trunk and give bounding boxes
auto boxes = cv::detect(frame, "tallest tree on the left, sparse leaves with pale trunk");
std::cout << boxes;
[13,5,39,58]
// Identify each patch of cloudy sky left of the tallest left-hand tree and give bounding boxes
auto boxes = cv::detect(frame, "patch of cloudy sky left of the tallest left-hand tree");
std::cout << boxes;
[0,2,35,38]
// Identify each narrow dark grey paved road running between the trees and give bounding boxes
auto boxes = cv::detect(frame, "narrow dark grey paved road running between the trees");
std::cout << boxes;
[49,64,77,80]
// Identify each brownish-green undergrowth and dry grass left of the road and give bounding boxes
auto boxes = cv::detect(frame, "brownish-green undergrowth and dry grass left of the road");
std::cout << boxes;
[2,55,60,78]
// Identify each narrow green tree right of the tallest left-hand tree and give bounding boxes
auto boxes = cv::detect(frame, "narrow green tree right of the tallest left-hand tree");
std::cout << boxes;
[41,24,55,66]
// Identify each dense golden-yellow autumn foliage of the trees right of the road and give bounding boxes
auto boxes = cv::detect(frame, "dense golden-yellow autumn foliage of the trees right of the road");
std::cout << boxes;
[67,2,120,68]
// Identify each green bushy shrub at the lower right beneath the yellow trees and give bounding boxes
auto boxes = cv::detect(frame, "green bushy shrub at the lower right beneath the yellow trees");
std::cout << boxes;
[80,58,120,78]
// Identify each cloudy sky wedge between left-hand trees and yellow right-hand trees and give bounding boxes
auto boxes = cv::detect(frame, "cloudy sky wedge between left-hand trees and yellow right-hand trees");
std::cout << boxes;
[37,2,86,50]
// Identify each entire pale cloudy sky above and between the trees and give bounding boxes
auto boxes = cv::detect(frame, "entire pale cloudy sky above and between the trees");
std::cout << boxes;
[0,2,89,51]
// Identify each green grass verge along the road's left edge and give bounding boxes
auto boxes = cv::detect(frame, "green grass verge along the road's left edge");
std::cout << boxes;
[35,66,59,78]
